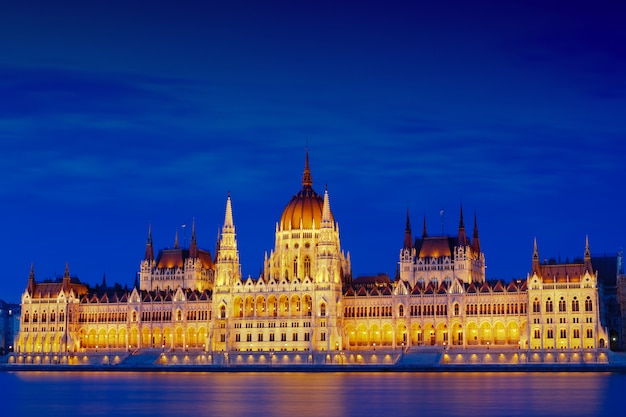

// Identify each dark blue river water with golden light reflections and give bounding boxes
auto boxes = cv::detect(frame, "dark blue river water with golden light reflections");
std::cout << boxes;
[0,372,626,417]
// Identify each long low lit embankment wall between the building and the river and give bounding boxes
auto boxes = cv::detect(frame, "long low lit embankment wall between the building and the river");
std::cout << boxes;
[0,349,626,372]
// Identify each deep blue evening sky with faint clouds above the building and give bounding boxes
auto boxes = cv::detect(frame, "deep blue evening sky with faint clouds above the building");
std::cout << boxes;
[0,0,626,301]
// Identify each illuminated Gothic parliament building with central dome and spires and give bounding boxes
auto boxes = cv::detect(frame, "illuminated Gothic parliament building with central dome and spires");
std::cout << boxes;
[15,152,608,355]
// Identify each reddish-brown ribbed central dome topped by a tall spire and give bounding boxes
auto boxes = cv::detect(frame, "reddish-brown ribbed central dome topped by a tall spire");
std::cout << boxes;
[280,152,334,230]
